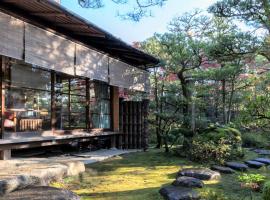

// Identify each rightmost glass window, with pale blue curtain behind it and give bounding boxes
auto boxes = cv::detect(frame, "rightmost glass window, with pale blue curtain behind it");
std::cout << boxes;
[90,81,111,129]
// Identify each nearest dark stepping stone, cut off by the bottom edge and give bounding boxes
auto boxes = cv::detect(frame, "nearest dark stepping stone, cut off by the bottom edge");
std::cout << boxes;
[159,185,200,200]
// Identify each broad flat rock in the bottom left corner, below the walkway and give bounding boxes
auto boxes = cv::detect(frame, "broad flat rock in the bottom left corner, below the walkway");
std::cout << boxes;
[0,186,80,200]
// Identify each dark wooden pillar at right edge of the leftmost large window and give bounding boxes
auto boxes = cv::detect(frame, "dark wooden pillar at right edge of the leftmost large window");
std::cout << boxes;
[51,71,57,133]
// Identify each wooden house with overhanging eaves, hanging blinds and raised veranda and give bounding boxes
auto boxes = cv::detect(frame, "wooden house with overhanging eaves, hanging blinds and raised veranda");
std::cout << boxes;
[0,0,159,159]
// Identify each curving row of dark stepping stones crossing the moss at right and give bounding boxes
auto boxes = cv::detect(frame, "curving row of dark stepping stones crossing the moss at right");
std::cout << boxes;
[159,149,270,200]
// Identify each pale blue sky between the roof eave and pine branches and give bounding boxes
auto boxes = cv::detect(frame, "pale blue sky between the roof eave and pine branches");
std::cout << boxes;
[61,0,216,44]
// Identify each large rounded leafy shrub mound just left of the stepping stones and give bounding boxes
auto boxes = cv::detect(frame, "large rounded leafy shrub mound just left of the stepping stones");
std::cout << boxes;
[190,127,243,164]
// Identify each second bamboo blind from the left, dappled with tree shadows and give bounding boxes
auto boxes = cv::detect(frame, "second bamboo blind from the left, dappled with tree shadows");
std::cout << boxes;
[25,24,75,75]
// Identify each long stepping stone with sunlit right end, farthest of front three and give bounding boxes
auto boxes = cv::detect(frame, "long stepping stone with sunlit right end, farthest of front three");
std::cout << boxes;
[178,168,221,180]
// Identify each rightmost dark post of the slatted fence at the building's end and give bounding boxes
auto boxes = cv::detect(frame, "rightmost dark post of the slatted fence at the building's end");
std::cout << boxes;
[142,99,149,151]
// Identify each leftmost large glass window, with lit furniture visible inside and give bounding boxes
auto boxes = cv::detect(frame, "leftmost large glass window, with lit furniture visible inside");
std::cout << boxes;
[4,61,51,132]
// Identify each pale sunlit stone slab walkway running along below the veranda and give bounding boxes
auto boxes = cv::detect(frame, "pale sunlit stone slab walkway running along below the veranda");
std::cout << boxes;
[0,149,138,196]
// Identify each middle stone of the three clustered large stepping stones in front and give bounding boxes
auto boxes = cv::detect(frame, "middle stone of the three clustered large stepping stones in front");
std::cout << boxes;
[172,176,204,188]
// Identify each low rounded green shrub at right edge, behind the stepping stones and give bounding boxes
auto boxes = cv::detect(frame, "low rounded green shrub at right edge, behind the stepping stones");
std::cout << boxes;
[242,132,269,148]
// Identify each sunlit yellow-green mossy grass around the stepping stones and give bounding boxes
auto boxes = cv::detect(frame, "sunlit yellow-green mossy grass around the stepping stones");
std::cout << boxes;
[53,149,270,200]
